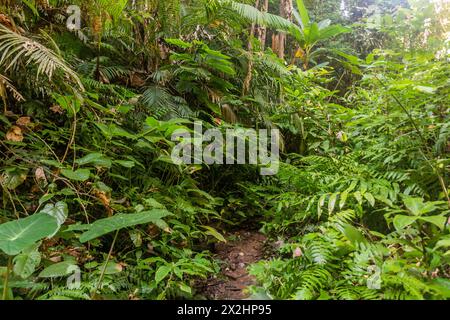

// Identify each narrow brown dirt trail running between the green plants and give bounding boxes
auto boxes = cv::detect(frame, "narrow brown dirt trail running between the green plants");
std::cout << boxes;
[203,231,266,300]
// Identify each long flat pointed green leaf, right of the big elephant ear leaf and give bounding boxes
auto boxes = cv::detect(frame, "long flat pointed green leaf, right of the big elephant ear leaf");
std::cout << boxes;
[80,209,171,243]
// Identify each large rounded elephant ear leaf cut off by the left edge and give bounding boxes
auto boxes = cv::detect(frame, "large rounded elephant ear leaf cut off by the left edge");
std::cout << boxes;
[0,213,59,256]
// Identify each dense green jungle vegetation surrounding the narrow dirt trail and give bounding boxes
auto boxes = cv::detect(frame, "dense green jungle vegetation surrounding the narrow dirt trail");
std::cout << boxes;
[0,0,450,300]
